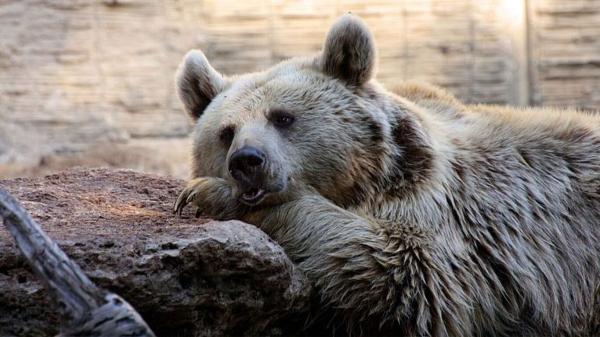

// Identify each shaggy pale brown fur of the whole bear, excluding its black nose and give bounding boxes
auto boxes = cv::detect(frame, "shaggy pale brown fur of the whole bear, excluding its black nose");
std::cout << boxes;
[176,15,600,336]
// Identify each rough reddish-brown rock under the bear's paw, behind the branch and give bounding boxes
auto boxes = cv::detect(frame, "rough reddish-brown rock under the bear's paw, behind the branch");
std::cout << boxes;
[0,169,312,336]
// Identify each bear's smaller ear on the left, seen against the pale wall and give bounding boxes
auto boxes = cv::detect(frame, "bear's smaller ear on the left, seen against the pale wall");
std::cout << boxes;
[175,50,225,120]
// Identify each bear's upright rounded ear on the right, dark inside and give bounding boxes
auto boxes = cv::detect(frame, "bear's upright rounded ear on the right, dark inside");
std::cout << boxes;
[322,14,376,85]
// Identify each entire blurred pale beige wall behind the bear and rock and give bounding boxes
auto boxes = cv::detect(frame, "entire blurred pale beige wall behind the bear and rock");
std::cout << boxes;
[0,0,600,178]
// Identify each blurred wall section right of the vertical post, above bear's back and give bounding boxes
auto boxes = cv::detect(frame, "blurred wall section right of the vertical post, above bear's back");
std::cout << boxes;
[529,0,600,110]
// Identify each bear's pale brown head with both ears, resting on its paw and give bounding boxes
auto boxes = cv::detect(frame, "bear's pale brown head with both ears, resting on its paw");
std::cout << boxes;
[177,15,389,206]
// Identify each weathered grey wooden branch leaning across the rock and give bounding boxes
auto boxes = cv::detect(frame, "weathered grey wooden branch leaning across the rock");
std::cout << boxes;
[0,189,154,337]
